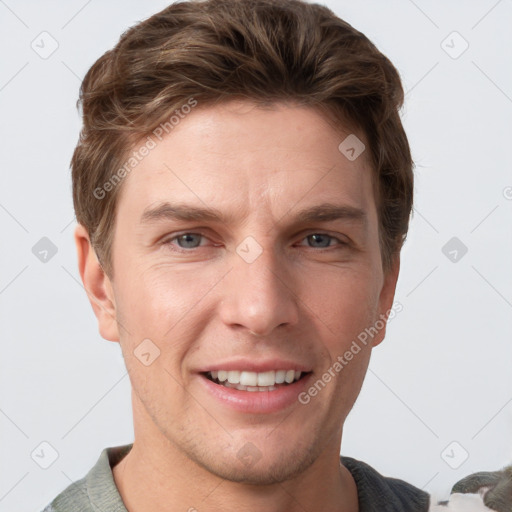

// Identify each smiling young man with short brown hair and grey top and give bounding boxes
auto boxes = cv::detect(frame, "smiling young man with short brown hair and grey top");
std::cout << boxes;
[46,0,508,512]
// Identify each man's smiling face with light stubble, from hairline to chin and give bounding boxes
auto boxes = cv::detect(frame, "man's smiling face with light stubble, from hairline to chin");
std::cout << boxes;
[81,102,398,484]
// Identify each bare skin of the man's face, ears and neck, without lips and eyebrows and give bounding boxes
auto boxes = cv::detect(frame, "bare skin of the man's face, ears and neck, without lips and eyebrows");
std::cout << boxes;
[75,102,399,512]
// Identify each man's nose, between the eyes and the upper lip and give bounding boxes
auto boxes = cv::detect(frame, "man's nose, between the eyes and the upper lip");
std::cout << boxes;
[220,239,299,336]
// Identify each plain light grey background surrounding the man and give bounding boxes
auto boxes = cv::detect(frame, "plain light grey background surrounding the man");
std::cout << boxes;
[0,0,512,512]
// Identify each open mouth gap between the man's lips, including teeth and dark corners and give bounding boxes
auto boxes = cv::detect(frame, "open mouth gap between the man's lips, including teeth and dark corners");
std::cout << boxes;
[202,370,311,392]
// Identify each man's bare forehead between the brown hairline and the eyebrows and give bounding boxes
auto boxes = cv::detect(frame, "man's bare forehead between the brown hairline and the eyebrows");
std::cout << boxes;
[118,102,374,225]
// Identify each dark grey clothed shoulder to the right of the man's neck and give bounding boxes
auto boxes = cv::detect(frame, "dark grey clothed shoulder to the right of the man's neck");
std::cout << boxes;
[340,456,430,512]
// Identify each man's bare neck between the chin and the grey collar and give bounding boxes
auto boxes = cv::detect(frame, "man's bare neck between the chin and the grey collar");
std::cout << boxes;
[113,396,358,512]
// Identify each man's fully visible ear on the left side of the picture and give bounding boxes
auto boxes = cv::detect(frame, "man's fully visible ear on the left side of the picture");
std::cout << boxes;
[75,224,119,341]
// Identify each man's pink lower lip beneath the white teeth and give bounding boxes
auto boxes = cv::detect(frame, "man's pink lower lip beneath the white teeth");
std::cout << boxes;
[199,373,312,414]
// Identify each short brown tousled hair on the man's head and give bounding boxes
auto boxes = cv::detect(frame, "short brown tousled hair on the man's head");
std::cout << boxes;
[71,0,413,275]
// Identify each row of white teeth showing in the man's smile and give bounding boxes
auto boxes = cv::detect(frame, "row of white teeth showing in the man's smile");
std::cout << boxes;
[210,370,302,391]
